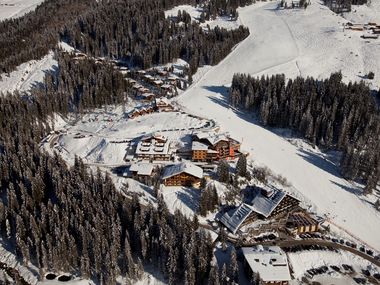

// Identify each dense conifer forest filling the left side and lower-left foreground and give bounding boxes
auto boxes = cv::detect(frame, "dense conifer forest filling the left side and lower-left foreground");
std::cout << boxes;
[0,51,226,284]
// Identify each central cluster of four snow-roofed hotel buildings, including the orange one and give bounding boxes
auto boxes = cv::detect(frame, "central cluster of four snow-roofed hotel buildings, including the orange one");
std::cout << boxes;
[125,131,241,187]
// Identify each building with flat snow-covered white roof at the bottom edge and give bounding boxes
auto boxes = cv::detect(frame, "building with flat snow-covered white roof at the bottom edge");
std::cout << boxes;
[241,245,291,285]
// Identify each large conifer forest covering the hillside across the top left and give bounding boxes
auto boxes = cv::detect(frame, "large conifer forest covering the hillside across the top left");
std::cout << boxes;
[0,0,252,72]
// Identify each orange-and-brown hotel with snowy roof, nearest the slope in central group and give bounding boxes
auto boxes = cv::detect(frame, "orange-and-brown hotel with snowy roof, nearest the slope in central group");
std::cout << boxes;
[192,132,240,162]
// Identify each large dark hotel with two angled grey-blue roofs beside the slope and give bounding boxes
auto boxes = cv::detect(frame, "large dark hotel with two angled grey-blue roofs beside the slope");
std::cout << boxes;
[220,188,300,234]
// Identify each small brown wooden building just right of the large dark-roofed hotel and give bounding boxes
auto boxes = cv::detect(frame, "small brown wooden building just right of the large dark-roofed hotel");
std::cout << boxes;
[286,212,320,235]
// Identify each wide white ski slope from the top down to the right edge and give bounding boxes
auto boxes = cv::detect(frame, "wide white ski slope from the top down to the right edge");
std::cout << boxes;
[178,2,380,250]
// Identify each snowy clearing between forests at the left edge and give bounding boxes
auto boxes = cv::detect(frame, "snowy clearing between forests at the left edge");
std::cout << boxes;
[0,51,58,94]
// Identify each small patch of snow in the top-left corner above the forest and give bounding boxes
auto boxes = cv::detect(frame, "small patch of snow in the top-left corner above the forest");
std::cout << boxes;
[0,0,43,21]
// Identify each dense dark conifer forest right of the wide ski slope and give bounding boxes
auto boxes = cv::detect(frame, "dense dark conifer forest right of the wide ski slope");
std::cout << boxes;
[229,73,380,193]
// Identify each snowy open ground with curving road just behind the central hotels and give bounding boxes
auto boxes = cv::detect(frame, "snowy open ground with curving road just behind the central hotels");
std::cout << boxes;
[45,105,211,166]
